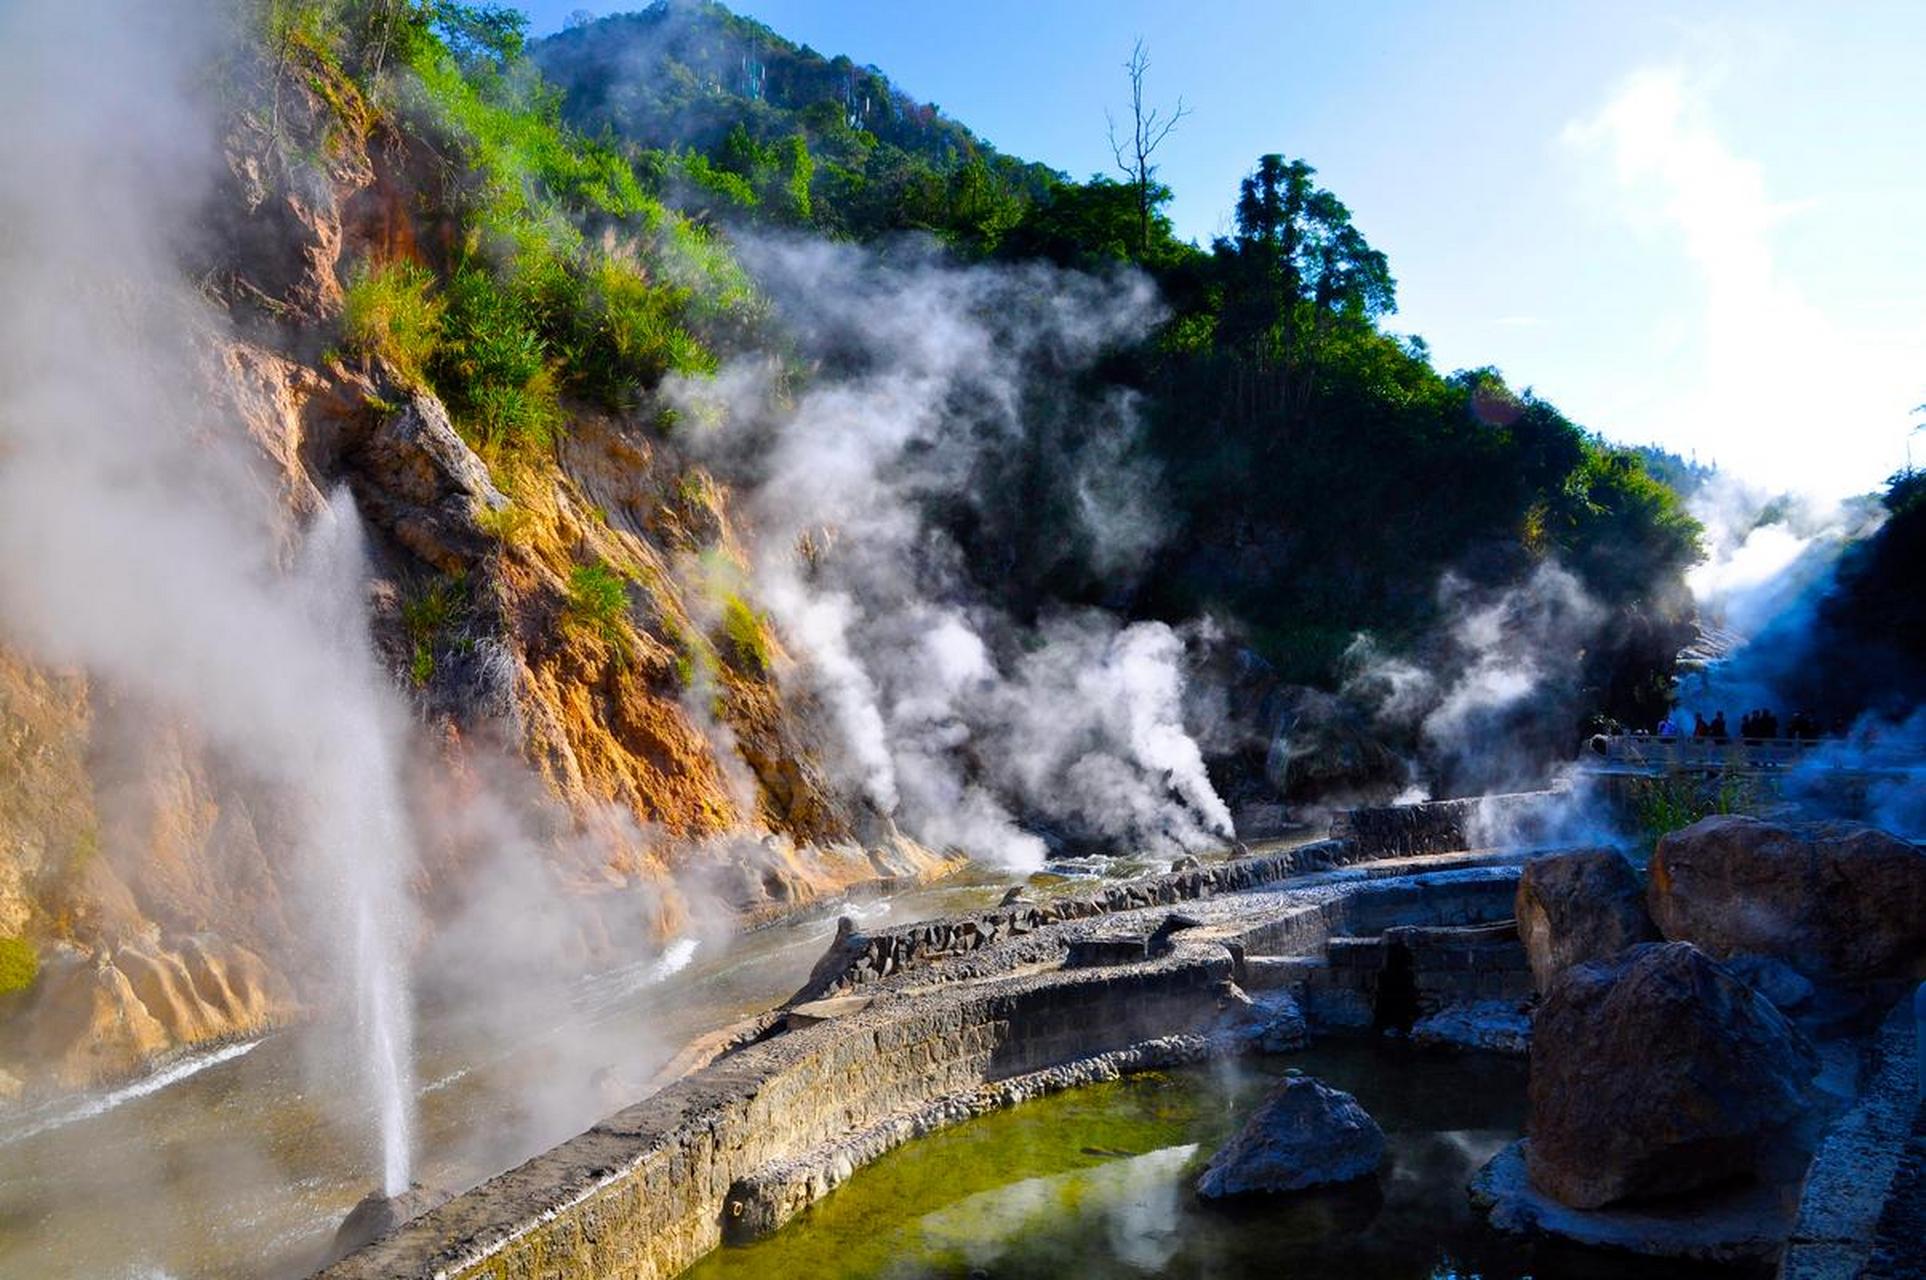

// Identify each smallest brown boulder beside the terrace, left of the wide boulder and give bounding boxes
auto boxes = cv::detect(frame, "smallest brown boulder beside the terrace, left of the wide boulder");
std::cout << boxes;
[1514,849,1658,993]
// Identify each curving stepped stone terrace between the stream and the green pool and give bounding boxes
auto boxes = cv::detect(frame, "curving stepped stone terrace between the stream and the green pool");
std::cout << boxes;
[322,804,1548,1280]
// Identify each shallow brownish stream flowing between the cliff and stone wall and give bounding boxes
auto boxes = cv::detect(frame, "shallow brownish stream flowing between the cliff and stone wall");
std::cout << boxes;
[0,843,1232,1280]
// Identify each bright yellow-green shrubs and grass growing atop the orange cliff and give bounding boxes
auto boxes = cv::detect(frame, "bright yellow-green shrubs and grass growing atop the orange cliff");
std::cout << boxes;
[281,0,758,464]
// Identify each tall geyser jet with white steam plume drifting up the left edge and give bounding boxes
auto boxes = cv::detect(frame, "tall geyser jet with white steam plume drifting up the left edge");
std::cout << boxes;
[0,0,412,1191]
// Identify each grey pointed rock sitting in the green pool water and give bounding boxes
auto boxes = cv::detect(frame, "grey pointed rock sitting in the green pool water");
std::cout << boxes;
[1198,1076,1385,1199]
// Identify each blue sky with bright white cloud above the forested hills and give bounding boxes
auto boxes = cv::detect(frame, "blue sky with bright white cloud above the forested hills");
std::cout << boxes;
[526,0,1926,495]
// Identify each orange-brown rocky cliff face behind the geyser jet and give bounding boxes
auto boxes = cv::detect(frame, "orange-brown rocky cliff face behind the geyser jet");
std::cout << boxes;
[0,34,944,1088]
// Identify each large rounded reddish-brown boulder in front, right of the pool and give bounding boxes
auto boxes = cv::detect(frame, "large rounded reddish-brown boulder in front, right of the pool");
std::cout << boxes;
[1527,943,1818,1209]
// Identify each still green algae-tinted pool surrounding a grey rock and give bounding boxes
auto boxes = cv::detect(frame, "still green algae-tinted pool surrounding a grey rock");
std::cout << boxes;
[688,1043,1733,1280]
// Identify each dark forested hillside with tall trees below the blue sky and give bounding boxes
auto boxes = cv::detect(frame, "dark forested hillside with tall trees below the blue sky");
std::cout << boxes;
[534,0,1699,800]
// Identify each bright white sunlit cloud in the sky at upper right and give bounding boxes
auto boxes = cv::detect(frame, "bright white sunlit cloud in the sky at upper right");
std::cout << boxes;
[1564,67,1926,497]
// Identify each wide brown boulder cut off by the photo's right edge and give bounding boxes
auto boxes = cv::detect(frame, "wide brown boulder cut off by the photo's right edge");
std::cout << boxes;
[1651,816,1926,982]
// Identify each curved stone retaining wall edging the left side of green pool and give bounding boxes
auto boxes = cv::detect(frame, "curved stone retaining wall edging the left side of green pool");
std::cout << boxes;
[322,941,1235,1280]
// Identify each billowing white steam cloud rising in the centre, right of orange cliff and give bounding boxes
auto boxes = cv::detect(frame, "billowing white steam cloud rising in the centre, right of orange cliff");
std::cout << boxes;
[672,241,1231,868]
